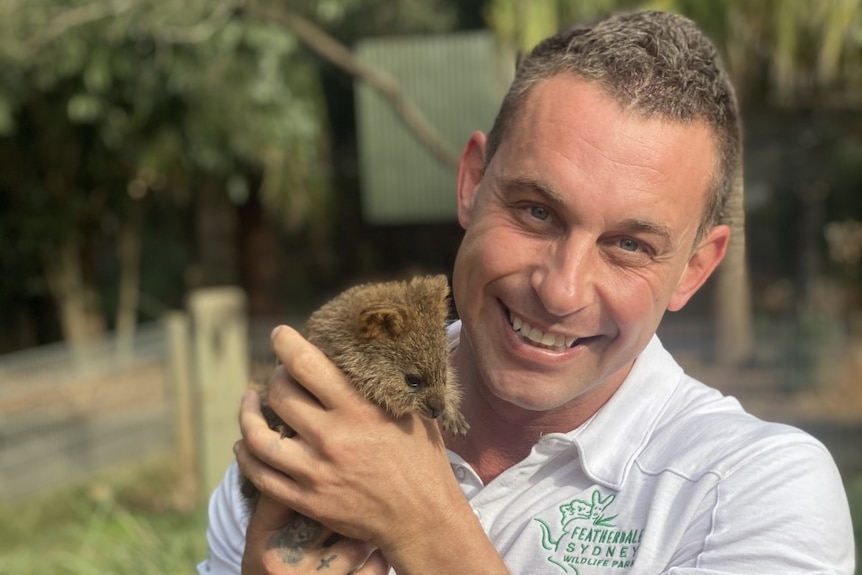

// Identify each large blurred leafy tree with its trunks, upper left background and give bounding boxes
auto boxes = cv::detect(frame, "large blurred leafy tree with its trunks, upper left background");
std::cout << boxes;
[0,0,328,354]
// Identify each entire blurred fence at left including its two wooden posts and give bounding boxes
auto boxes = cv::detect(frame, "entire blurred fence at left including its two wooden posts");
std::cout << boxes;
[0,288,249,499]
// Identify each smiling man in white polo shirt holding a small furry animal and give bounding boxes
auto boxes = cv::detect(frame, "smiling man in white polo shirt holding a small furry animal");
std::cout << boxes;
[201,12,854,575]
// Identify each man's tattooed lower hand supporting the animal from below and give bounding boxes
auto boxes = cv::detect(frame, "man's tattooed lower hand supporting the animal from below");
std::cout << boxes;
[240,486,389,575]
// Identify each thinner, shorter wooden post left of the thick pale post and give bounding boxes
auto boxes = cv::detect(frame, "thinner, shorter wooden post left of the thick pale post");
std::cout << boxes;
[164,311,201,498]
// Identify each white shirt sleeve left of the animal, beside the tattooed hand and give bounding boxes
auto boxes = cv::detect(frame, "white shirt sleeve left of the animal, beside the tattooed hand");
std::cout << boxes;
[197,463,248,575]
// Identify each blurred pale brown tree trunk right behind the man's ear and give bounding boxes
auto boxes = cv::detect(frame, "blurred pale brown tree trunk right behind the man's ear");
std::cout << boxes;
[715,162,754,366]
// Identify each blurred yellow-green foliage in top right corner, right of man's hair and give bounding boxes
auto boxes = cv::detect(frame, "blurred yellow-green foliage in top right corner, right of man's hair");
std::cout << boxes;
[642,0,862,106]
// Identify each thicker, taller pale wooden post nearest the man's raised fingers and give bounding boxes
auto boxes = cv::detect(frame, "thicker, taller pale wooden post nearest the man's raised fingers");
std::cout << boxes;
[189,287,249,497]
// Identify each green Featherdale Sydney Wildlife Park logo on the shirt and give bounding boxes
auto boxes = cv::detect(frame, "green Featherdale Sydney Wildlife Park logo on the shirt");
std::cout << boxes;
[535,489,643,575]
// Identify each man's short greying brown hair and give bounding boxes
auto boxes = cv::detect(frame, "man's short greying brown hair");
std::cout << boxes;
[485,11,742,238]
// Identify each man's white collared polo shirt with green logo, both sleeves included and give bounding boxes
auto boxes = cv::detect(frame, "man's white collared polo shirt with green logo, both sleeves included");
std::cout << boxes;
[198,324,855,575]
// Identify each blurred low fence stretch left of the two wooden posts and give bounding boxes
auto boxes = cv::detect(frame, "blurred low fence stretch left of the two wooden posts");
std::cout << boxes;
[0,324,174,498]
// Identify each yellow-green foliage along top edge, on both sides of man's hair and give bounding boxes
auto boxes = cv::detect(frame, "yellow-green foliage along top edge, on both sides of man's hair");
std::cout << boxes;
[488,0,862,105]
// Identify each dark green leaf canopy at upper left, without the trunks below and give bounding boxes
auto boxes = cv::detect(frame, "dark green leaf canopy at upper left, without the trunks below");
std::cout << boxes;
[0,0,334,208]
